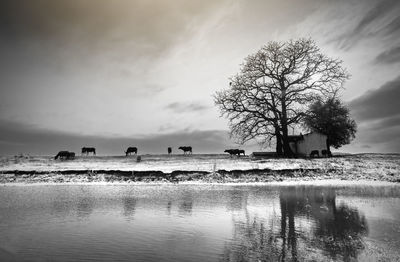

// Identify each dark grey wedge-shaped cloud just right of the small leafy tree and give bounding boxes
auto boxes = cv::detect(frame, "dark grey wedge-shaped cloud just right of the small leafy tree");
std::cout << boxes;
[350,76,400,121]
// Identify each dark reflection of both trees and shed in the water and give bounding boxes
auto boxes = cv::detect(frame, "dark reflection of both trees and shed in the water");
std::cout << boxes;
[222,187,368,261]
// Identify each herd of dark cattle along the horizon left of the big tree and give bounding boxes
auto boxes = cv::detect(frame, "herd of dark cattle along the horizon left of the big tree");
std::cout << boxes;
[54,146,245,160]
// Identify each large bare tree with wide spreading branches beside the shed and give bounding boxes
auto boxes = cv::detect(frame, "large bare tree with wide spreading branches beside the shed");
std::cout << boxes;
[214,39,349,156]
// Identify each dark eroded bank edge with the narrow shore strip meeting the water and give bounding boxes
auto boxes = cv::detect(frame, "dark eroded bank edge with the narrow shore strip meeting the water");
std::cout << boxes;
[0,168,400,184]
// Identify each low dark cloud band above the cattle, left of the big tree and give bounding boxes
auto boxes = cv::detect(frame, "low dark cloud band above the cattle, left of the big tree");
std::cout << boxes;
[0,120,241,155]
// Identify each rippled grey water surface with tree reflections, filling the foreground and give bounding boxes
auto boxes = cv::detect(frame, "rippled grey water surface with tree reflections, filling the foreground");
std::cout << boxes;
[0,185,400,261]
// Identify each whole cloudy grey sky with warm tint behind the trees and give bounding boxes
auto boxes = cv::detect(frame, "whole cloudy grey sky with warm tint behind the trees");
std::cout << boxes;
[0,0,400,154]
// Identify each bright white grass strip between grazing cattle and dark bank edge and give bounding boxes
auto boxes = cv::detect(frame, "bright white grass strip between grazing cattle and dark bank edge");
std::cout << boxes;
[0,155,324,173]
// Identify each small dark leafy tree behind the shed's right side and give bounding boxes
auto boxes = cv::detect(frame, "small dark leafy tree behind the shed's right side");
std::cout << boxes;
[304,97,357,150]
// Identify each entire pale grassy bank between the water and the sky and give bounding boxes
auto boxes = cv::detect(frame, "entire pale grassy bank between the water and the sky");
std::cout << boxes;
[0,154,400,184]
